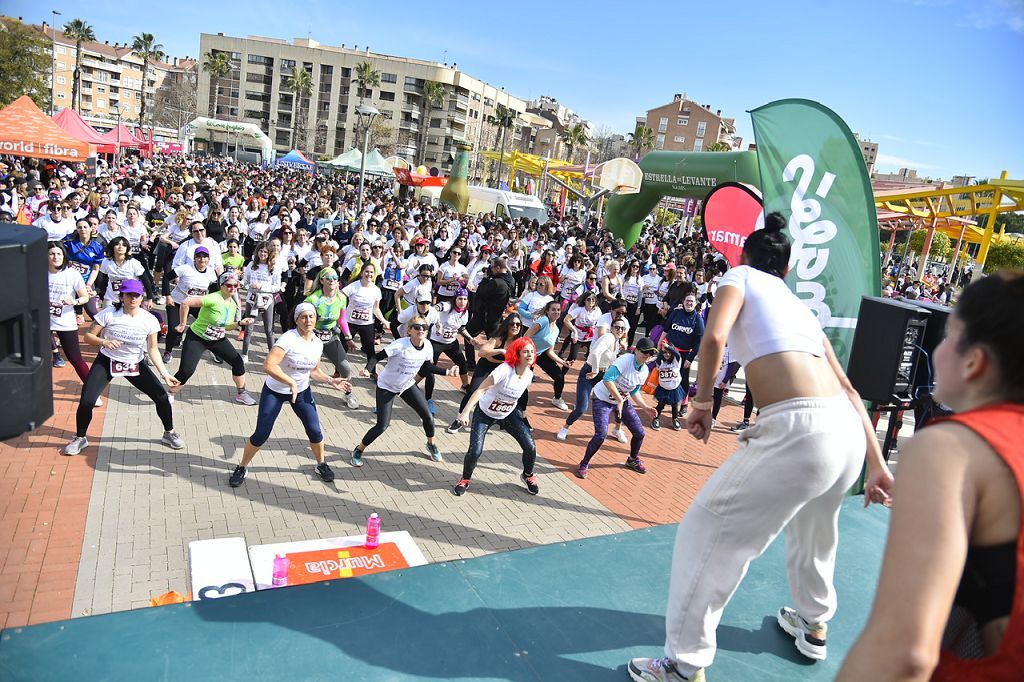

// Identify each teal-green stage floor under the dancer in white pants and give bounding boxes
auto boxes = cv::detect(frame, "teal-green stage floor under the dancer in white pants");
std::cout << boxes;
[0,497,888,681]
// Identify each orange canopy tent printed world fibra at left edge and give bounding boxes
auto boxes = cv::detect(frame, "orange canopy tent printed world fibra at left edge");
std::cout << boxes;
[0,95,95,161]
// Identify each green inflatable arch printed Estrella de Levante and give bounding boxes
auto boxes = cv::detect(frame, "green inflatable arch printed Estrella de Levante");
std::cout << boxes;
[604,152,761,248]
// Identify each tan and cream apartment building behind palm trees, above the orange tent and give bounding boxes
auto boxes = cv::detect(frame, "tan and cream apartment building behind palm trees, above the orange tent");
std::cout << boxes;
[36,23,196,139]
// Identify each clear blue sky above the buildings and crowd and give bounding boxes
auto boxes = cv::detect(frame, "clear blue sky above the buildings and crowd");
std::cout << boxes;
[9,0,1024,178]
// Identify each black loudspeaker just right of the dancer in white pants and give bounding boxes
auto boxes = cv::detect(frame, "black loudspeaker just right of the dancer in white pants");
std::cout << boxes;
[847,296,929,403]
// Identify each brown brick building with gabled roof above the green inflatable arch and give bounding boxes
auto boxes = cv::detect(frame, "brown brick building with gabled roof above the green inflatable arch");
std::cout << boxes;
[637,93,743,152]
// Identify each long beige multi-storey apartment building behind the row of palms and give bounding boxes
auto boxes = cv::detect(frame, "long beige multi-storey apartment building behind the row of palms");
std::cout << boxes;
[198,33,526,170]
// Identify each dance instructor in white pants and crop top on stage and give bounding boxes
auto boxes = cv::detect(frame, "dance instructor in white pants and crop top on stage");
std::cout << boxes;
[629,213,893,682]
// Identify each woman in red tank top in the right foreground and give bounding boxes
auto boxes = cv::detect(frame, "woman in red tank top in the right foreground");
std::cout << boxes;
[839,271,1024,682]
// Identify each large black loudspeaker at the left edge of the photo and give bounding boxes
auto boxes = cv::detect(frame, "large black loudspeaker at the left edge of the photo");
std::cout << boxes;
[0,223,53,439]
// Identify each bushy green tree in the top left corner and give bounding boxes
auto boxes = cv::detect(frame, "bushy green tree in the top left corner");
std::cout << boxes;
[0,17,52,110]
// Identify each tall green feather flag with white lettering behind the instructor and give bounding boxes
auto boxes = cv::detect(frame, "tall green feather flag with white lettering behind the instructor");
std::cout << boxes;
[751,99,882,367]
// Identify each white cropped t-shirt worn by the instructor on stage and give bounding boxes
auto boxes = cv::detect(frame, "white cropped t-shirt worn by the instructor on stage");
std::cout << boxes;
[718,265,825,367]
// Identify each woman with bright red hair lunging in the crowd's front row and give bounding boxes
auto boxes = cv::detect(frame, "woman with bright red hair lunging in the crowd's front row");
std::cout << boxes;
[453,338,541,496]
